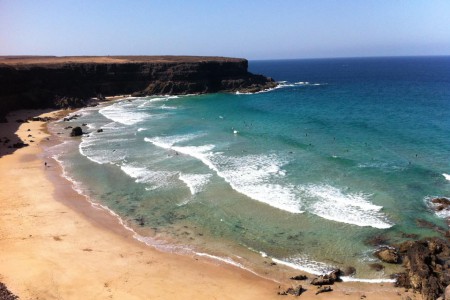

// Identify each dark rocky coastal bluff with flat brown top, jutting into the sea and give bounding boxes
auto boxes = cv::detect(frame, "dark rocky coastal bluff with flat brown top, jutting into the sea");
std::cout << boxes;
[0,56,276,121]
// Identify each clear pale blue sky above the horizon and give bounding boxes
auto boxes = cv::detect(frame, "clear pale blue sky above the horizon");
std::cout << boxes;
[0,0,450,60]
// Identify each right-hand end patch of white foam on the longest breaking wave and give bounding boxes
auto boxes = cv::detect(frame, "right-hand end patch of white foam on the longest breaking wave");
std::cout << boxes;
[300,185,393,229]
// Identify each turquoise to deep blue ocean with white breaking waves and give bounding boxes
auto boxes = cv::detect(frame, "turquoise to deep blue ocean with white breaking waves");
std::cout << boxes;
[47,57,450,282]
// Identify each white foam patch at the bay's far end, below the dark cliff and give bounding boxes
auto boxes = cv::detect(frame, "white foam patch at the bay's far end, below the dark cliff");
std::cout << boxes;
[98,102,149,125]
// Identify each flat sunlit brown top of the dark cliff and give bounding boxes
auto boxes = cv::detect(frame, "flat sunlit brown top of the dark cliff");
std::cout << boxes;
[0,56,245,67]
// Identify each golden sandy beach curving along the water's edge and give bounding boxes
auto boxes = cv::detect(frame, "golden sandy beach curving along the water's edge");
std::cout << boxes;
[0,110,414,299]
